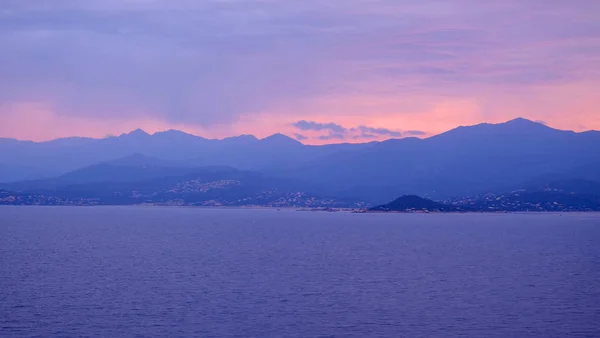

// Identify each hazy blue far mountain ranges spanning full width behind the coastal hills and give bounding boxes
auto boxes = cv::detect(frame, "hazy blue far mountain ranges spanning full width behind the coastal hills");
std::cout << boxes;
[0,119,600,203]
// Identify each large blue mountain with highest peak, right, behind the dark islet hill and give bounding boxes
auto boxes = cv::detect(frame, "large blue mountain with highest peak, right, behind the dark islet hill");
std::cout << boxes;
[278,119,600,203]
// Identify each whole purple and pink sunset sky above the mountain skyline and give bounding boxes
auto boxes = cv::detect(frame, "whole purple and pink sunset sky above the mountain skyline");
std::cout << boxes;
[0,0,600,144]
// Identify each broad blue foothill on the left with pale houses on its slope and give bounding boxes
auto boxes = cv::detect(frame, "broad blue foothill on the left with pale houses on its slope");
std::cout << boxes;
[0,163,364,207]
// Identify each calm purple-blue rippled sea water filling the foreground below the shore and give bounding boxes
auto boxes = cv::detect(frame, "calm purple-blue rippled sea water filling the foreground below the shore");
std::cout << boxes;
[0,207,600,338]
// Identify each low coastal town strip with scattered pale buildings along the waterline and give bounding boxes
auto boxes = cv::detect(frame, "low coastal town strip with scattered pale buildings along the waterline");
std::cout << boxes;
[0,187,600,212]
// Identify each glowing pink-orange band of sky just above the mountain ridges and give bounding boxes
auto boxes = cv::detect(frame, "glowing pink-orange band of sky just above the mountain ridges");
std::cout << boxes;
[0,87,600,144]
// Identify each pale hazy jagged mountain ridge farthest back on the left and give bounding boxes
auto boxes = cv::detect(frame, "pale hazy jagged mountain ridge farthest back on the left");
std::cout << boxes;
[0,129,338,182]
